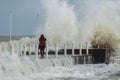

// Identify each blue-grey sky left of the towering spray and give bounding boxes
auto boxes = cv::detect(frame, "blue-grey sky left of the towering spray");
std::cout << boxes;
[0,0,45,35]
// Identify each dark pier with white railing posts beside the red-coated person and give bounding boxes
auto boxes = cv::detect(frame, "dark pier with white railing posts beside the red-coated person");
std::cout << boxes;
[17,43,109,64]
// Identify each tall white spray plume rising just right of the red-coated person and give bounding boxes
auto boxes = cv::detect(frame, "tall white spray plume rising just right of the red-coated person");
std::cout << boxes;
[41,0,77,44]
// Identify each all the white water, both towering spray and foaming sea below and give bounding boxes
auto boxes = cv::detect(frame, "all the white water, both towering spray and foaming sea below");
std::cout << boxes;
[0,0,120,80]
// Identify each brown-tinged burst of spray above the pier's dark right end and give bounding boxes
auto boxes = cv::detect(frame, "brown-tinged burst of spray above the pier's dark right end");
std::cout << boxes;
[92,21,120,49]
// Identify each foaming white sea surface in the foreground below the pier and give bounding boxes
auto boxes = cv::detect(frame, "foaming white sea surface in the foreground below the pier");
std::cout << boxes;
[0,37,120,80]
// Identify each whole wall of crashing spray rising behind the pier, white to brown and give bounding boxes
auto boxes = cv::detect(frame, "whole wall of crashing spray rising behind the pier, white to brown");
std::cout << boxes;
[38,0,120,49]
